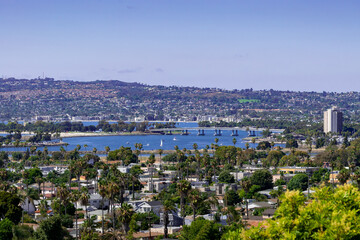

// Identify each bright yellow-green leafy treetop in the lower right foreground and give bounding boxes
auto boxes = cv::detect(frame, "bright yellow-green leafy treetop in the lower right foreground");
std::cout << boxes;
[223,184,360,240]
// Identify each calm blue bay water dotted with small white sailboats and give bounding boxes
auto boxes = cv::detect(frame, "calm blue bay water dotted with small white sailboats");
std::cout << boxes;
[0,122,284,151]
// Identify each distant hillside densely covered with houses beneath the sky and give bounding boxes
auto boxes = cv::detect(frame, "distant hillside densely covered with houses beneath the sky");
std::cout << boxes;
[0,78,360,120]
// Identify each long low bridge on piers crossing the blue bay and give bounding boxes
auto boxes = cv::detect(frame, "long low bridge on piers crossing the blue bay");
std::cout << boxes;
[150,127,255,137]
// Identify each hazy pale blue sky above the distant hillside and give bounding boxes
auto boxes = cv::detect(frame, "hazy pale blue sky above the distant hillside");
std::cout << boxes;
[0,0,360,92]
